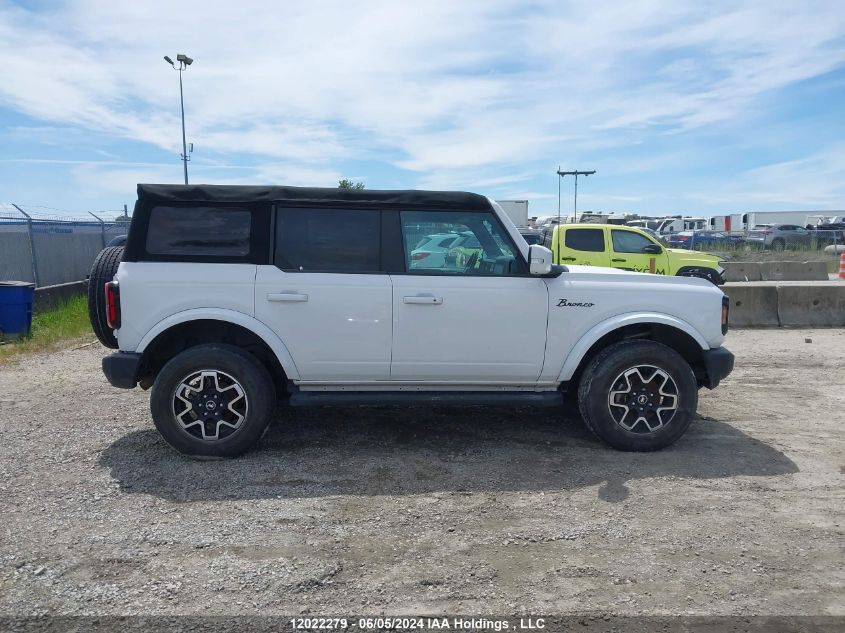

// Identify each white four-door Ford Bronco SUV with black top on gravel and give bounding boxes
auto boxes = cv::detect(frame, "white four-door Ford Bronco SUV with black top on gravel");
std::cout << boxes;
[90,185,733,457]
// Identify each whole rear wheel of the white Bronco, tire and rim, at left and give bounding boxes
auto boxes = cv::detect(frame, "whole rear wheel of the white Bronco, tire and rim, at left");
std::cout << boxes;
[150,344,276,457]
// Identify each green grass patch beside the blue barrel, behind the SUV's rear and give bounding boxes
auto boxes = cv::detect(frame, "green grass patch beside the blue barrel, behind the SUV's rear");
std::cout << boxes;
[0,296,94,363]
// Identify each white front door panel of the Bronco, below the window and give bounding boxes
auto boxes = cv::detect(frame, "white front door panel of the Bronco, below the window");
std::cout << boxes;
[390,275,548,383]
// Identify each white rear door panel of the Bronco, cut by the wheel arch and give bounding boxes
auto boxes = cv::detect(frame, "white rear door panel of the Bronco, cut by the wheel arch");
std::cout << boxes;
[255,266,392,382]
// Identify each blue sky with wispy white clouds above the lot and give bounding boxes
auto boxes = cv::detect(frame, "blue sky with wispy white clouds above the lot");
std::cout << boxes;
[0,0,845,215]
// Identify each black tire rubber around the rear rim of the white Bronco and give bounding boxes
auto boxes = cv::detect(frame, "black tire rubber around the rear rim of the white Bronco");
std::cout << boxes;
[150,343,276,458]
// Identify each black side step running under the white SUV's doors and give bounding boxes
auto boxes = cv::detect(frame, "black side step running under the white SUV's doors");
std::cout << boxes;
[288,391,563,407]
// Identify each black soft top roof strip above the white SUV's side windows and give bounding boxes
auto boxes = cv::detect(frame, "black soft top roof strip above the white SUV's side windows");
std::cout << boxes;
[138,184,490,210]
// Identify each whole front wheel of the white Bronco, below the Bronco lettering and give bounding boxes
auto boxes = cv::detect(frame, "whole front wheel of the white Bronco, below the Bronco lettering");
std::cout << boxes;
[578,341,698,451]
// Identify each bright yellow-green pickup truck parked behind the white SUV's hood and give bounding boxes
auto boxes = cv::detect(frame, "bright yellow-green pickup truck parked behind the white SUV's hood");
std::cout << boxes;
[543,224,725,285]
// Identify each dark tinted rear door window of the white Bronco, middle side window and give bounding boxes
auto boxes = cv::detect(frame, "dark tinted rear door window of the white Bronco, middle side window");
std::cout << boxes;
[274,208,381,273]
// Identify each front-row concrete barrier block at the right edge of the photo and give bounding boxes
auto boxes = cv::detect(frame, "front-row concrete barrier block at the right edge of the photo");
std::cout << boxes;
[777,285,845,327]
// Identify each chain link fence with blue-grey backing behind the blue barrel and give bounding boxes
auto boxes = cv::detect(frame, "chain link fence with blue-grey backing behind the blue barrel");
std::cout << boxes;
[0,203,129,287]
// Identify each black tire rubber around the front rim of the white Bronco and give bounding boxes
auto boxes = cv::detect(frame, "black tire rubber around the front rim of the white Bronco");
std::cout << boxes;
[578,340,698,451]
